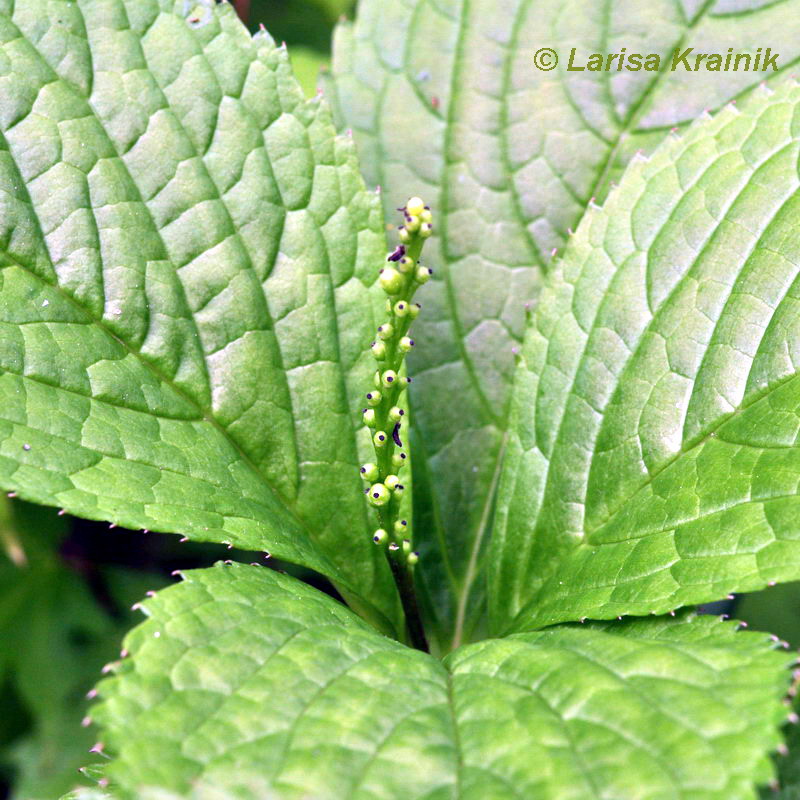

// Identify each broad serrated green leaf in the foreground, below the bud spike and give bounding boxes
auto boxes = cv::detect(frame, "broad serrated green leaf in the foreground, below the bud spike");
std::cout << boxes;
[93,565,793,800]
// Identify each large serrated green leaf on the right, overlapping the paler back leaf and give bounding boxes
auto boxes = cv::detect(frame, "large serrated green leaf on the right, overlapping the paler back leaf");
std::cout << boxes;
[490,84,800,630]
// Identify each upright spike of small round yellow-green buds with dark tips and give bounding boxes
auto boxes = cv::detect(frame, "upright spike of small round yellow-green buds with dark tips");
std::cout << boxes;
[361,197,433,566]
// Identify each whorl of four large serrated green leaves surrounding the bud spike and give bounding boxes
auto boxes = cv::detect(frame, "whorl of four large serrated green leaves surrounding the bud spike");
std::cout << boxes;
[0,0,800,800]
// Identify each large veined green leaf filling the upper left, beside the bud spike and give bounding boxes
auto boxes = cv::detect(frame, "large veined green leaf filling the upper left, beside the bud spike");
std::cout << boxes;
[0,0,398,630]
